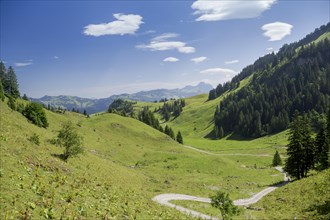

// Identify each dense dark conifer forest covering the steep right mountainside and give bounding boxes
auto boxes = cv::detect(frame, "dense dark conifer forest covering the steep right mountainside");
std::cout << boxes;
[210,23,330,137]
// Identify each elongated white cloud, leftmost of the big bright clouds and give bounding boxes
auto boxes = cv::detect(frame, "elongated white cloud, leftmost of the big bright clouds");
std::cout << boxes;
[84,14,143,37]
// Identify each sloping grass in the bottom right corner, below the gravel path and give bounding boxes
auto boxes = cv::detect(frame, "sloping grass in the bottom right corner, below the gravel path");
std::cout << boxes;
[249,169,330,219]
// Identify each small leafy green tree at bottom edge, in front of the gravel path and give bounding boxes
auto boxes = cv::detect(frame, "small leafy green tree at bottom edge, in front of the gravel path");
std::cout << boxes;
[211,191,239,219]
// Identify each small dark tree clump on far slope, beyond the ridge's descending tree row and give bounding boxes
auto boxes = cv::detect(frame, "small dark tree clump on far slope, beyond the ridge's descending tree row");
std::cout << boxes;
[158,99,186,121]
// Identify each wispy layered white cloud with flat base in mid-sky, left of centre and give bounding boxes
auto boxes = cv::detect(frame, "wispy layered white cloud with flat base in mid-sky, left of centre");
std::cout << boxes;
[136,33,195,53]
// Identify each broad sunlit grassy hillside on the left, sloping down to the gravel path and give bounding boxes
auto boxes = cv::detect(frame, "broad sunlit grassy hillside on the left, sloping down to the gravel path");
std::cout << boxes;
[0,99,281,219]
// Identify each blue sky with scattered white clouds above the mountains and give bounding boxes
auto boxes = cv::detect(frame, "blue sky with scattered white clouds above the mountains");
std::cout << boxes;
[0,0,330,98]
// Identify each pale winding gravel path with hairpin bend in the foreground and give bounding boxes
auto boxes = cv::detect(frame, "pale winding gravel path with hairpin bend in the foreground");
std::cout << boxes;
[152,167,290,219]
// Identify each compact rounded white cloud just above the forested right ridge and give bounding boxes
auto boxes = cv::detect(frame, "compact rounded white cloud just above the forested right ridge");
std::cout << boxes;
[261,22,293,41]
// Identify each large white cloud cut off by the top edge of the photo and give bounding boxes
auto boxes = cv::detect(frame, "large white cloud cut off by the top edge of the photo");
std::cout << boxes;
[191,0,276,21]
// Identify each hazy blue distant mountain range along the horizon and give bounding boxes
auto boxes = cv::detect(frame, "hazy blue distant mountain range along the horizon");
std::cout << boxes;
[30,82,213,114]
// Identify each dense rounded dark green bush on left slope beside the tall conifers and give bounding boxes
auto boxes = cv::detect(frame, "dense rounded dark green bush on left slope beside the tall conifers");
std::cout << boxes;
[23,102,48,128]
